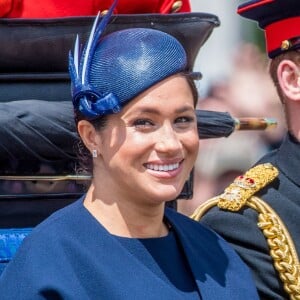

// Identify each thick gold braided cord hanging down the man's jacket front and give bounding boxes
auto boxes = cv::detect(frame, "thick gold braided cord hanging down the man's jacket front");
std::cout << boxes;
[246,196,300,300]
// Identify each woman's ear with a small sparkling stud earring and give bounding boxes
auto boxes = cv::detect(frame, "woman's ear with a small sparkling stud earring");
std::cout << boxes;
[77,120,100,155]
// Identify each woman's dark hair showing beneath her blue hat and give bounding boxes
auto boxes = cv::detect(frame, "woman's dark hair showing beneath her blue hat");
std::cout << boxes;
[74,73,199,174]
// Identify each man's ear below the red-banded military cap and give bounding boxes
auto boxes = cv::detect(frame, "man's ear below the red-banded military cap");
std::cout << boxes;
[277,59,300,101]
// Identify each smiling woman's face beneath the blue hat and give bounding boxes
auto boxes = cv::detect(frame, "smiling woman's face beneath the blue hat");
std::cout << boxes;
[94,75,199,203]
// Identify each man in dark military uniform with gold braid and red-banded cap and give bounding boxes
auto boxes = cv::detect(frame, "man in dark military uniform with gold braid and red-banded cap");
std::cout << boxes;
[192,0,300,300]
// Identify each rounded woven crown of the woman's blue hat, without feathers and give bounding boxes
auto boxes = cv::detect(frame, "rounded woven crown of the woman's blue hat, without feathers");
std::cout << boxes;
[85,28,187,114]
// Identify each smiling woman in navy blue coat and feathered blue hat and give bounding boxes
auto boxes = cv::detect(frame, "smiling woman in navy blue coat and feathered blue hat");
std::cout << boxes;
[0,2,257,300]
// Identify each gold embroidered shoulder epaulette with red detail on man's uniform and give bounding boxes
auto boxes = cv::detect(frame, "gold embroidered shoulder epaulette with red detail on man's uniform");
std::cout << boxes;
[217,163,279,211]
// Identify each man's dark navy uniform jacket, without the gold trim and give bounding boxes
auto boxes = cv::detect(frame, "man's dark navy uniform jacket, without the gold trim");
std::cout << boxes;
[200,134,300,300]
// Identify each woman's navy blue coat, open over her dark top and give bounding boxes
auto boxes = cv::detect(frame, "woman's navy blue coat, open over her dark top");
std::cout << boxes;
[0,199,258,300]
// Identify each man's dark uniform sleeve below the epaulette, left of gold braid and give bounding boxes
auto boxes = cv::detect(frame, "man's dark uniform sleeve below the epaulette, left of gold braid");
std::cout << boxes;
[200,207,288,300]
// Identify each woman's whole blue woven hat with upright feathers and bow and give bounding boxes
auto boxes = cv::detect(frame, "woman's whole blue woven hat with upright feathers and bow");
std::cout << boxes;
[69,1,219,119]
